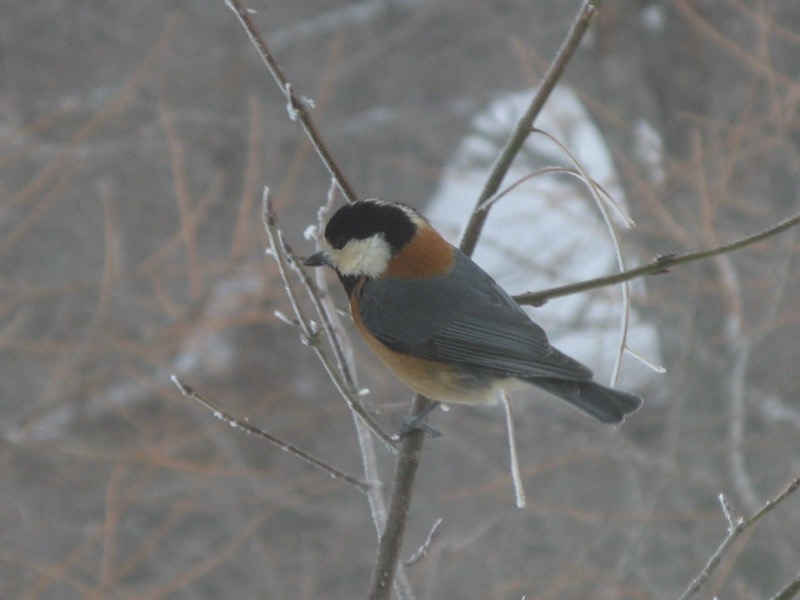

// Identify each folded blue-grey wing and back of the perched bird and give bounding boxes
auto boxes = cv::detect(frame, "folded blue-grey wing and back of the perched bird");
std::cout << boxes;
[359,251,592,380]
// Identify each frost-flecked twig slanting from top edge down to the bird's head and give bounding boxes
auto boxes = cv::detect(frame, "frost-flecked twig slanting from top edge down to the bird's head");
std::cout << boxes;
[219,0,358,202]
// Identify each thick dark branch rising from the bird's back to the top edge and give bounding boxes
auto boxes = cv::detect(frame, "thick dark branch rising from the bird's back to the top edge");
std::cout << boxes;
[459,0,602,256]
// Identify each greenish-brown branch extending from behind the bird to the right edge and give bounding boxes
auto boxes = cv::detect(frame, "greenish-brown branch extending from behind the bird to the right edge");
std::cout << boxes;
[514,209,800,306]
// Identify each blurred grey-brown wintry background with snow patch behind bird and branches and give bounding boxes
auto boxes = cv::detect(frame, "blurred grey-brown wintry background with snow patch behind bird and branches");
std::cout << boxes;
[0,0,800,600]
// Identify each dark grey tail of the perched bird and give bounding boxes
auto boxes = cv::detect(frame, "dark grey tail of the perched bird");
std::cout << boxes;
[527,377,642,425]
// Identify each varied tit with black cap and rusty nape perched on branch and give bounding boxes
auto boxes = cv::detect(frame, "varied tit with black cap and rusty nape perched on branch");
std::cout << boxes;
[305,200,642,423]
